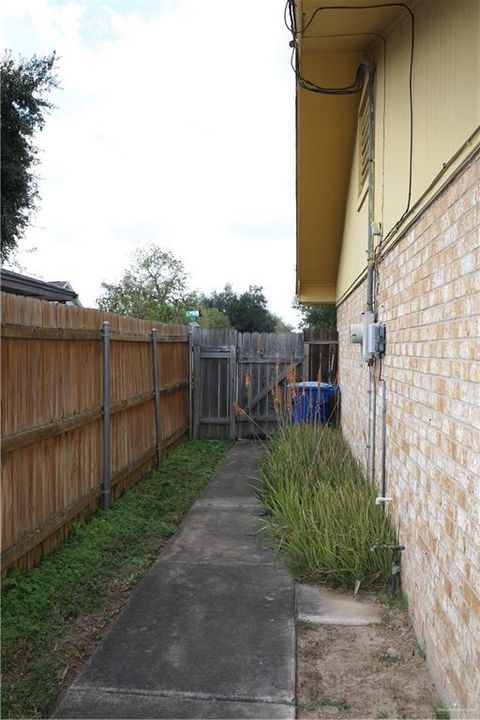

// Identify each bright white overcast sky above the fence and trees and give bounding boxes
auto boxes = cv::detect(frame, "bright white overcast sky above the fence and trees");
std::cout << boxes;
[0,0,297,323]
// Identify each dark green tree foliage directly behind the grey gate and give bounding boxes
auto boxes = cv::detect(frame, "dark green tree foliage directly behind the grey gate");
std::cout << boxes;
[203,284,279,332]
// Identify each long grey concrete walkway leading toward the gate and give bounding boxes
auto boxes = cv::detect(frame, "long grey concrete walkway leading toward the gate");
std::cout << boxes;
[54,440,295,719]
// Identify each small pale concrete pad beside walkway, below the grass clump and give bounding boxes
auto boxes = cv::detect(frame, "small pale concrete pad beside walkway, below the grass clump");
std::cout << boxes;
[295,584,381,625]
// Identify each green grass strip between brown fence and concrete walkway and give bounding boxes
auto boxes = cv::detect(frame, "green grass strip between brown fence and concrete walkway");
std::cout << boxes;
[2,440,232,718]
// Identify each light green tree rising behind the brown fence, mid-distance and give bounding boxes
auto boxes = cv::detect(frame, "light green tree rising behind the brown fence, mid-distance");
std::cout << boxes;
[97,244,194,323]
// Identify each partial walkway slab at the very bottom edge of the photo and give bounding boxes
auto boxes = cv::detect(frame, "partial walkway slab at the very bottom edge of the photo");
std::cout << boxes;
[54,688,295,720]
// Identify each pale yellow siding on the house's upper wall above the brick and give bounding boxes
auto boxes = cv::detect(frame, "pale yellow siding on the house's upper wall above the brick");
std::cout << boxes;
[337,0,480,299]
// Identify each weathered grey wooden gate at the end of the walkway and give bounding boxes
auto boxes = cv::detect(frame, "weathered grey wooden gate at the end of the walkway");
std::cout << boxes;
[192,328,304,439]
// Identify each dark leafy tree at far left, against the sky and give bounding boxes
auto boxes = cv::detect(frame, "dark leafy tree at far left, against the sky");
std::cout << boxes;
[0,52,59,260]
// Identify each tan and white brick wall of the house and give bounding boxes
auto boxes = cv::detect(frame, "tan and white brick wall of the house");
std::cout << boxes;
[338,159,480,718]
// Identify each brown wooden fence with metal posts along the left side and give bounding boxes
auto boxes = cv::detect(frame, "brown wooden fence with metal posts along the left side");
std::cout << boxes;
[1,293,189,568]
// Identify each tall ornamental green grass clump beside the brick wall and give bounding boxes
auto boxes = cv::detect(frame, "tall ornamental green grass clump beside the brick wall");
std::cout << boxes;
[261,423,395,587]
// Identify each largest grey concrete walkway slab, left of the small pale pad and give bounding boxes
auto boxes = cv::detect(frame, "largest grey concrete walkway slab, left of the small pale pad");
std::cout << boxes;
[71,562,294,702]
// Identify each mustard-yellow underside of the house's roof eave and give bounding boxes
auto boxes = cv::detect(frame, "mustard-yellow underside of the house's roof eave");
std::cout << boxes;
[296,0,414,303]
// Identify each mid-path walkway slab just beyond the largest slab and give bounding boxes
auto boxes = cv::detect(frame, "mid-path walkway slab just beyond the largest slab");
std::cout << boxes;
[159,504,274,565]
